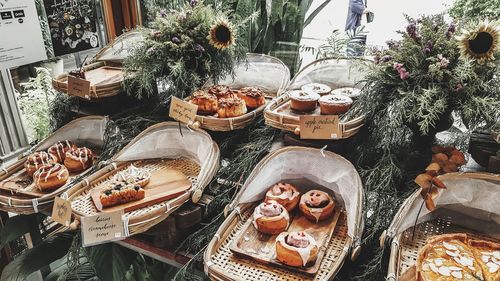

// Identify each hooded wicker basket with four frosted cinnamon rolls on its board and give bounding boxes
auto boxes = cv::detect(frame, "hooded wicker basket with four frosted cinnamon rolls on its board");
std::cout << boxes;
[204,147,363,280]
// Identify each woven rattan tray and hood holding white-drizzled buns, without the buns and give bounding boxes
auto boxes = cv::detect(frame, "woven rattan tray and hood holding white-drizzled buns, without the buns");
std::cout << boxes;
[0,116,107,214]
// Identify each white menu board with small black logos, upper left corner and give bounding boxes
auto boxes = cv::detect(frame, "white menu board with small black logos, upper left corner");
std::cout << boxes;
[0,0,47,69]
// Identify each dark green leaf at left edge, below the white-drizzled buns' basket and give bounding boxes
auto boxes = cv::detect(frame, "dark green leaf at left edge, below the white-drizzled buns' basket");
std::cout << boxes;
[0,213,46,249]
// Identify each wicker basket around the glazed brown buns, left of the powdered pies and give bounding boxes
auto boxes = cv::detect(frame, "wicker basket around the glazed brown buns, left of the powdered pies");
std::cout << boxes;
[195,53,290,131]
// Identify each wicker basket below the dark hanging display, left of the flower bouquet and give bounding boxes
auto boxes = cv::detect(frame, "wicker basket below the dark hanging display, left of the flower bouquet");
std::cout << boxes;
[52,31,141,100]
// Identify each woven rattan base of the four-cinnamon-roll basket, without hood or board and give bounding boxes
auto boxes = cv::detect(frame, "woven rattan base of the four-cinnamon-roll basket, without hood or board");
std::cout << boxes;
[205,204,352,280]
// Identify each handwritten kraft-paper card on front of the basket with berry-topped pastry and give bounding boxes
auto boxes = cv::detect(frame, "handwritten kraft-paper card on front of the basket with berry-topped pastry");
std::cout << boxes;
[82,210,125,247]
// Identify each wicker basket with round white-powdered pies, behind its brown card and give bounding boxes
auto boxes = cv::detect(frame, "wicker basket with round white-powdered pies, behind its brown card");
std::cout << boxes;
[264,58,369,139]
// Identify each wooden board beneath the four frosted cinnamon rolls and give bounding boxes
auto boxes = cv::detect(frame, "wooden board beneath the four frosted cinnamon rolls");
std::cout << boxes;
[230,207,341,275]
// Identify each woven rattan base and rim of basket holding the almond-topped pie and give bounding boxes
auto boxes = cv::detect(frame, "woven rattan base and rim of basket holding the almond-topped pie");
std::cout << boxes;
[381,173,500,281]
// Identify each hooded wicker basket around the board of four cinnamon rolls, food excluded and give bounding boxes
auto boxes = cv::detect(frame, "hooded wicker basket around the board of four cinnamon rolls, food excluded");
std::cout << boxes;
[204,147,363,280]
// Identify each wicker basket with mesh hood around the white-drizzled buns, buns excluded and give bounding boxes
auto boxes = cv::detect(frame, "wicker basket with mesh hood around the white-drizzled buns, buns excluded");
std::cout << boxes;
[0,116,108,214]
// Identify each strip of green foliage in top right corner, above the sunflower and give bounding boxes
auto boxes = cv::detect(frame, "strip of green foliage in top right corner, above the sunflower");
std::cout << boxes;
[449,0,500,20]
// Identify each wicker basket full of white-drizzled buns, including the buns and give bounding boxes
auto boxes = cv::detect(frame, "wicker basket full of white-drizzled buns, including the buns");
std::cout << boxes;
[0,116,107,213]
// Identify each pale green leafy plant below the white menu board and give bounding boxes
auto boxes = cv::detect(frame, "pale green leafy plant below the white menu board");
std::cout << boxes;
[17,67,57,142]
